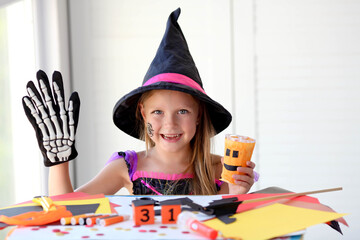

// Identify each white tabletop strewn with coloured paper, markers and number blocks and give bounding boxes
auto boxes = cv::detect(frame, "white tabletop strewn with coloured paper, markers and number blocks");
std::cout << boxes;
[0,188,348,240]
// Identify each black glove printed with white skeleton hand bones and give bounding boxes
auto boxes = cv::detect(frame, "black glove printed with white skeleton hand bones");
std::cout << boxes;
[22,70,80,167]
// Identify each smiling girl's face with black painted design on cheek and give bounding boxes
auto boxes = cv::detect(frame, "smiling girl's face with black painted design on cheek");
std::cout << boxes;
[140,90,199,152]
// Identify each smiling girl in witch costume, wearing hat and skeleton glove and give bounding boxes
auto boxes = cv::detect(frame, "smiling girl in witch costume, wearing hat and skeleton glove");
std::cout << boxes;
[23,9,255,195]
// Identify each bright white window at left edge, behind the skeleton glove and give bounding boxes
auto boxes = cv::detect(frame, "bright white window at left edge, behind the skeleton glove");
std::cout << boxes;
[0,0,42,239]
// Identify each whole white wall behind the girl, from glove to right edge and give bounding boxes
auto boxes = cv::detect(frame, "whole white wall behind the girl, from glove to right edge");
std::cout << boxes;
[69,0,360,239]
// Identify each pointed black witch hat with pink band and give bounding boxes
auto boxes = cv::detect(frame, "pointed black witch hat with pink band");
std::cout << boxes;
[113,8,232,138]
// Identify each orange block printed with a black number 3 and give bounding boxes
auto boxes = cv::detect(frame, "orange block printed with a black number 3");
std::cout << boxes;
[132,200,155,225]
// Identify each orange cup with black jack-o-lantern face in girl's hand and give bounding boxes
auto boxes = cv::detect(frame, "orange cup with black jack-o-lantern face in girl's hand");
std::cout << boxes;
[221,135,255,183]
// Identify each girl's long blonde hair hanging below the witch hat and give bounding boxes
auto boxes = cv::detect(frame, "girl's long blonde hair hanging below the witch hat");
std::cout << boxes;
[136,90,217,195]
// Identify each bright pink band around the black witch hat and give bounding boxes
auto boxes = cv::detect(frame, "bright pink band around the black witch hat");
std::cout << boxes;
[143,73,207,95]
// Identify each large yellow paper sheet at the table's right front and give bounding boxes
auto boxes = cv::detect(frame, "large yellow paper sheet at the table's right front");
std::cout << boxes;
[204,203,346,240]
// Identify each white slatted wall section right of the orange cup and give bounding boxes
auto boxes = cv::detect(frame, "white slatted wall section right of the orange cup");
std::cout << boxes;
[250,1,360,239]
